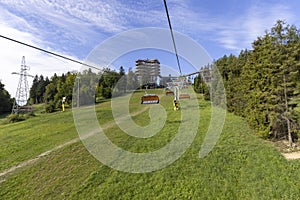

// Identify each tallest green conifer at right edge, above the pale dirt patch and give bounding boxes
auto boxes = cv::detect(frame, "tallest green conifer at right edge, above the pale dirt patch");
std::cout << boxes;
[242,21,299,142]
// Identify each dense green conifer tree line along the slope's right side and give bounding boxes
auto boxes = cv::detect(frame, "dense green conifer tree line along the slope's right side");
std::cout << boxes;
[194,20,300,145]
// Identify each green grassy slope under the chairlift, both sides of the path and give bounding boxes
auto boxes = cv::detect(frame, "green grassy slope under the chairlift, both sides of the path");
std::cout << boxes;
[0,89,300,199]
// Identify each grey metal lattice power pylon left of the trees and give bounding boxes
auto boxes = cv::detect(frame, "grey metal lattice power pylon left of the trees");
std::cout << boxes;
[11,56,33,114]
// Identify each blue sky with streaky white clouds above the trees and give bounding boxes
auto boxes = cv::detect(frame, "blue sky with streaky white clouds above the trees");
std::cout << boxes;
[0,0,300,96]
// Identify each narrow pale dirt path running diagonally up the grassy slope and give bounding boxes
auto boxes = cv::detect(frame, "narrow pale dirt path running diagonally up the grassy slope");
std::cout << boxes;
[0,107,148,183]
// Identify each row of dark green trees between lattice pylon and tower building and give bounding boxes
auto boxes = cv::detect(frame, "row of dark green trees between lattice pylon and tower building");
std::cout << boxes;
[29,66,138,112]
